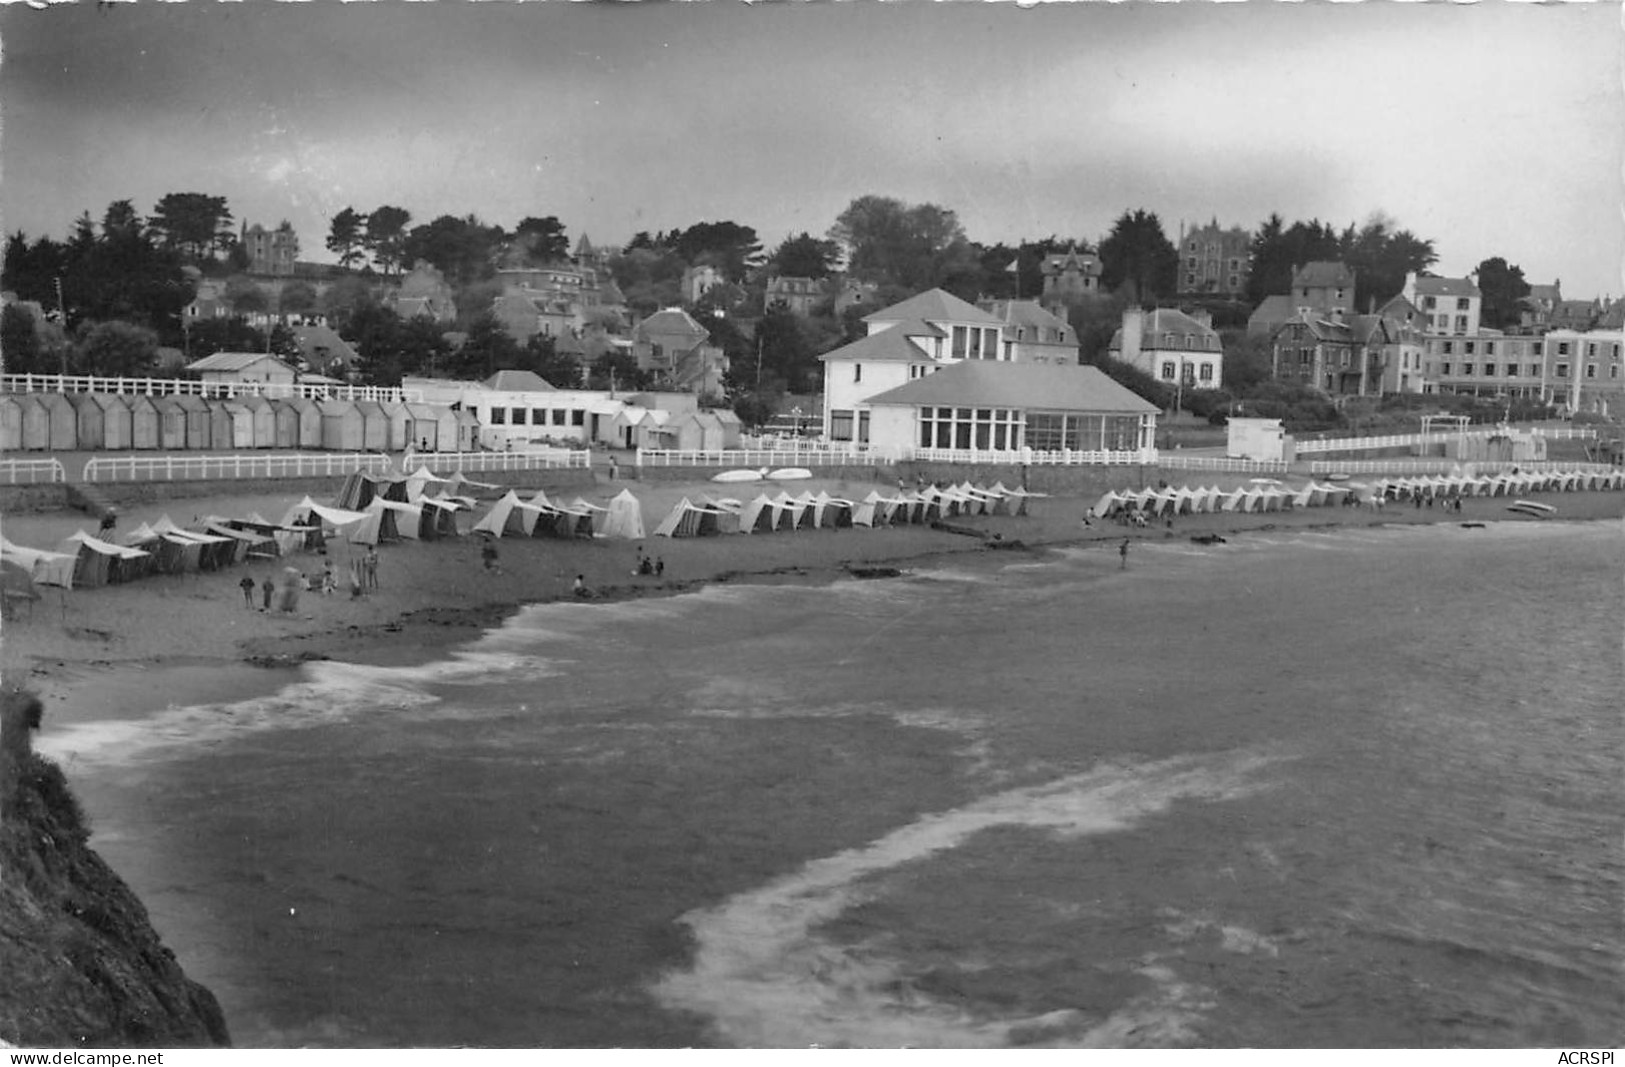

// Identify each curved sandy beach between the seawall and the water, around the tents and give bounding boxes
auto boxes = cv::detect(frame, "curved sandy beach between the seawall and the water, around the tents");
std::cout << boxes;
[0,476,1625,718]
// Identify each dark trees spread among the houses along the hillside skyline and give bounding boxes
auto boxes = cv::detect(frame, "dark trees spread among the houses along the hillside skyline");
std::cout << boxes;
[0,193,1529,431]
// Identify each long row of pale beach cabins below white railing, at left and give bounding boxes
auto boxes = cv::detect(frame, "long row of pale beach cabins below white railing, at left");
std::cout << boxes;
[0,393,479,451]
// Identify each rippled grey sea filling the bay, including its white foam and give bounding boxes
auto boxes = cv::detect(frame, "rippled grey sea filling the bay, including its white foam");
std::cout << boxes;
[42,523,1625,1048]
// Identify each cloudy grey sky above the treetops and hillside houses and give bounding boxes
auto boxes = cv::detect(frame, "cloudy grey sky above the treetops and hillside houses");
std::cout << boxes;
[0,0,1625,297]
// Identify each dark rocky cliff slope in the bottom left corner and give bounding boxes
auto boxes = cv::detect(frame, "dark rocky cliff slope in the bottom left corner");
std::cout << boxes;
[0,692,231,1049]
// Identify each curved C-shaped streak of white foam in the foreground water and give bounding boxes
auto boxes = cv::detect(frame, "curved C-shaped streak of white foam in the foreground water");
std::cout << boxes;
[655,743,1274,1048]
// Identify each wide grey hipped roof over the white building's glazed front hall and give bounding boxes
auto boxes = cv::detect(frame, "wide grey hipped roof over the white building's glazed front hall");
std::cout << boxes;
[868,359,1157,414]
